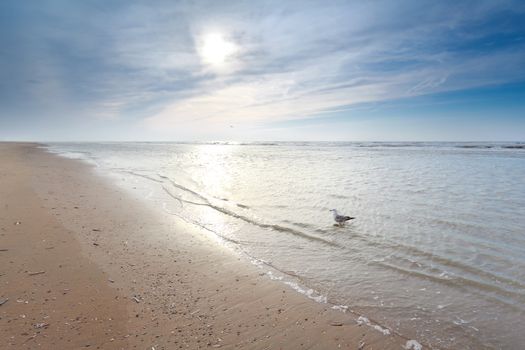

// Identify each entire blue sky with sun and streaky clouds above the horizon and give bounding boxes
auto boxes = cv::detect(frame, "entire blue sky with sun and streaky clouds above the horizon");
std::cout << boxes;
[0,0,525,141]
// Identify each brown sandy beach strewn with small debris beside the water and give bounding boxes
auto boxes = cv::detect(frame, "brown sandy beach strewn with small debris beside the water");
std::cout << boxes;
[0,143,407,350]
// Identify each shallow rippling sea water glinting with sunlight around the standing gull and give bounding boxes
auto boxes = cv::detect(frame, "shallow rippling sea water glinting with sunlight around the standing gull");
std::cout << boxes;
[48,142,525,349]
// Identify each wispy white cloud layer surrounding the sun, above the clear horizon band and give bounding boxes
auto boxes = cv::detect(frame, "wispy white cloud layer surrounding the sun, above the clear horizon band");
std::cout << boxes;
[0,1,525,139]
